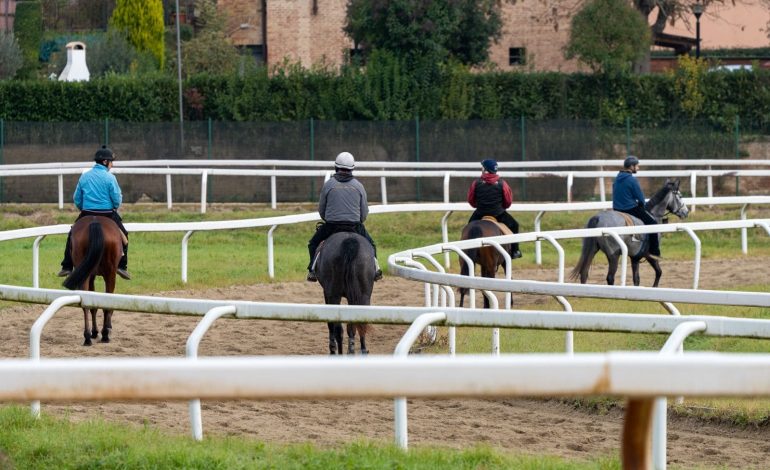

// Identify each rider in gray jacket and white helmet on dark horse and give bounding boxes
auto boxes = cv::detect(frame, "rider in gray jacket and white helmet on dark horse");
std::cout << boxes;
[307,152,382,282]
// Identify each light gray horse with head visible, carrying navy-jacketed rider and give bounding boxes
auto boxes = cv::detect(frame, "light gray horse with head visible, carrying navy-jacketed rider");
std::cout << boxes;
[570,180,689,287]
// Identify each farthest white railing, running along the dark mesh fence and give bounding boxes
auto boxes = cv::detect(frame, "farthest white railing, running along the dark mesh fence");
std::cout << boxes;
[0,160,770,213]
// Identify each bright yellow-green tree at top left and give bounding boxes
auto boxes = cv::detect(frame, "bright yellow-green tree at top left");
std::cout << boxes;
[110,0,165,69]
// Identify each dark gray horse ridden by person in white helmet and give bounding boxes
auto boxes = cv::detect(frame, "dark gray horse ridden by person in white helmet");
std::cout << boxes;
[315,232,377,354]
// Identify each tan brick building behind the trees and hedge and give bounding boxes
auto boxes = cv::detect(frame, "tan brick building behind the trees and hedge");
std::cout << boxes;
[218,0,578,72]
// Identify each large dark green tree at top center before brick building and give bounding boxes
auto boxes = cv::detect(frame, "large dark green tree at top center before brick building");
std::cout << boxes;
[344,0,502,65]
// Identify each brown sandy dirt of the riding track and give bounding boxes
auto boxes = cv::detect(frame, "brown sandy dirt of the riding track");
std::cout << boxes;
[0,258,770,468]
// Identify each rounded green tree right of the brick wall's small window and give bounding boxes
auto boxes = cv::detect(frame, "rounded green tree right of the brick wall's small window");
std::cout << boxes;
[564,0,650,72]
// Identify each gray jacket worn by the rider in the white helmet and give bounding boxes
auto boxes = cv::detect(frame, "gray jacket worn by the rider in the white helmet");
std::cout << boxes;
[318,173,369,223]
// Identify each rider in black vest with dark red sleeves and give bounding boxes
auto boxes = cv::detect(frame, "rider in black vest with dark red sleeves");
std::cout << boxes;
[468,159,521,259]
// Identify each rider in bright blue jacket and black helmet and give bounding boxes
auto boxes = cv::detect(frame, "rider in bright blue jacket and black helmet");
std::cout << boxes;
[58,145,131,280]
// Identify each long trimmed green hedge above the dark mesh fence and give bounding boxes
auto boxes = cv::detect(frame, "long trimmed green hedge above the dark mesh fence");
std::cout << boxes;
[0,61,770,129]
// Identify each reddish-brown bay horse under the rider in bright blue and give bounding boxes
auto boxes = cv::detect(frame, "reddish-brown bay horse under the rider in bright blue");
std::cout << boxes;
[63,216,123,346]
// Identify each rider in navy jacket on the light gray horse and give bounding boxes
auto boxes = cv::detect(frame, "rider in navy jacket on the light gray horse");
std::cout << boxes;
[612,155,660,258]
